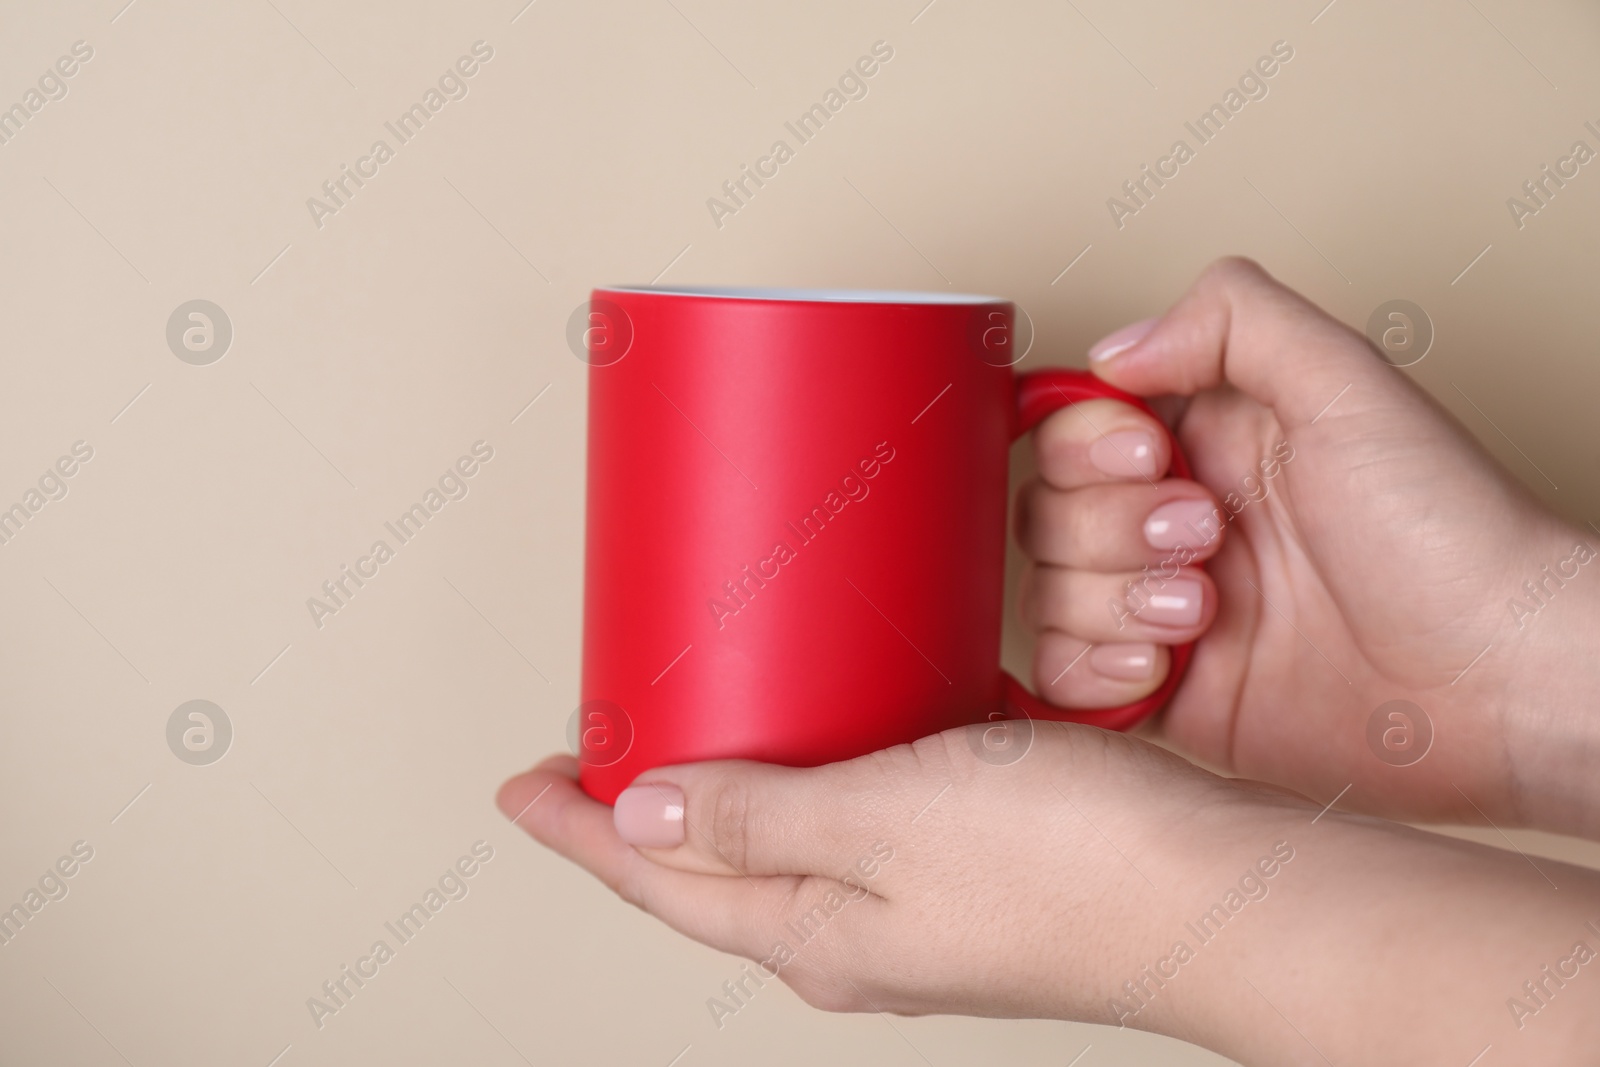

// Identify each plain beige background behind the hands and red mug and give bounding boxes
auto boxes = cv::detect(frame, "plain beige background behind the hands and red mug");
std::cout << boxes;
[0,0,1600,1067]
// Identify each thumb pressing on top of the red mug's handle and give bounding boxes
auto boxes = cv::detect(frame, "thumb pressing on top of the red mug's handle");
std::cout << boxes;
[1090,258,1421,427]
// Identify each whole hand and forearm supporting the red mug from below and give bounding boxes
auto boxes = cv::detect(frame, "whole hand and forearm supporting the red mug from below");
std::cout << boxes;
[498,723,1600,1067]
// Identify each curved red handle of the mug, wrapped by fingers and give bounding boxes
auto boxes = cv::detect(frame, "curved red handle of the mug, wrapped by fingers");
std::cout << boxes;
[1002,370,1194,729]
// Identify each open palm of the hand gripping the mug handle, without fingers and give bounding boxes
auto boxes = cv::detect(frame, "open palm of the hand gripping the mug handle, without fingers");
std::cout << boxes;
[1165,379,1542,817]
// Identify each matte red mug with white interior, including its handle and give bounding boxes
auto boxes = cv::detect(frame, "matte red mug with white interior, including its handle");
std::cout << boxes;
[571,286,1190,803]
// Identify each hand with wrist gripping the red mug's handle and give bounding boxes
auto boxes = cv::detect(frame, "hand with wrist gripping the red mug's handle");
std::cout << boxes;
[1019,259,1600,835]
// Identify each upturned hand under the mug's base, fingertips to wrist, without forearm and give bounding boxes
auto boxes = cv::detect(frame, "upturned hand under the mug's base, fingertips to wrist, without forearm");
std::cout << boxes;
[499,723,1222,1017]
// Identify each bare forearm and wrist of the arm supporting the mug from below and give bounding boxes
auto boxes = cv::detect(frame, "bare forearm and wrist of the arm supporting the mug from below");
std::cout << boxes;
[1091,784,1600,1062]
